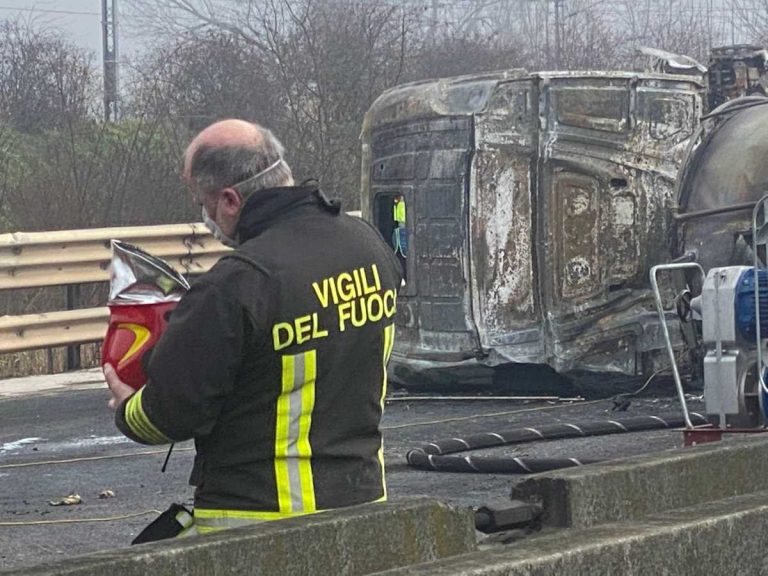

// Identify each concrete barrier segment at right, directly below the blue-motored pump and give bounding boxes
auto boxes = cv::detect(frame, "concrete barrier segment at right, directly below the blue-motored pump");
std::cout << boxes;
[512,435,768,528]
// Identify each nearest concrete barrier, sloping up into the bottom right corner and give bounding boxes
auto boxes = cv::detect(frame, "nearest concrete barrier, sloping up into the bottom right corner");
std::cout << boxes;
[379,492,768,576]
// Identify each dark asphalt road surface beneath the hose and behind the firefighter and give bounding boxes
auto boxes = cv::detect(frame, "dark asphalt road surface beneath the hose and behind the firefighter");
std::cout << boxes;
[0,382,702,570]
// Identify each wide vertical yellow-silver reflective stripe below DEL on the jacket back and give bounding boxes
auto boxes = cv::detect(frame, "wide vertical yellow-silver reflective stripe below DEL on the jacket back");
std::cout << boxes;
[275,350,317,515]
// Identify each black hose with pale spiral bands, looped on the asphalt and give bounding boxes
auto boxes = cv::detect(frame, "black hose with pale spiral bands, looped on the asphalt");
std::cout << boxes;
[405,412,708,474]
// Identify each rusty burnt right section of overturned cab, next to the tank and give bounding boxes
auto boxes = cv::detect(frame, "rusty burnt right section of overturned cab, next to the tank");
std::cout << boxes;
[538,73,700,374]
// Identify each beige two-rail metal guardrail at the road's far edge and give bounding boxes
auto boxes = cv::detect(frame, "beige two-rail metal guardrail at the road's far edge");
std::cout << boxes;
[0,223,229,353]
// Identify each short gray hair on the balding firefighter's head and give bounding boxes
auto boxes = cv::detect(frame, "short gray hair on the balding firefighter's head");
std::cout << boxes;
[190,127,293,198]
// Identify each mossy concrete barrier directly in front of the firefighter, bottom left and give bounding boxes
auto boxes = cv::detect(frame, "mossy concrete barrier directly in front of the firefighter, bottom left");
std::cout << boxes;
[0,499,476,576]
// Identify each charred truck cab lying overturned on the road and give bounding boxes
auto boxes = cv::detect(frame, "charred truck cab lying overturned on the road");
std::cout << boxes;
[362,70,702,384]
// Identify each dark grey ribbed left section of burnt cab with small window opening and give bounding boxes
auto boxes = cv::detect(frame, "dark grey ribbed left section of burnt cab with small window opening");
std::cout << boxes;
[363,77,510,374]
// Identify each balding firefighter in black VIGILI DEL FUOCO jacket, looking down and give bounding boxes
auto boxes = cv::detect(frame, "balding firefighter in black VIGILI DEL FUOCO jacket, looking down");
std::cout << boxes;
[104,120,401,541]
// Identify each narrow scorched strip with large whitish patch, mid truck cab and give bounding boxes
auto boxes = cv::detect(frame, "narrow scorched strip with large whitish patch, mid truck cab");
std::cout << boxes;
[470,79,543,359]
